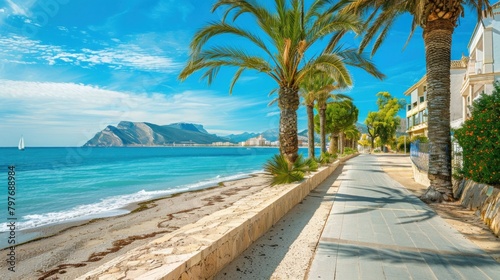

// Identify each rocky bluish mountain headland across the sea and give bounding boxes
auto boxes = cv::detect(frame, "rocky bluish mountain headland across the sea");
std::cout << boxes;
[84,121,227,147]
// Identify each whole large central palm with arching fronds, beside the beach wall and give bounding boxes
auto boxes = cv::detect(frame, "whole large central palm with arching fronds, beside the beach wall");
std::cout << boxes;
[179,0,378,165]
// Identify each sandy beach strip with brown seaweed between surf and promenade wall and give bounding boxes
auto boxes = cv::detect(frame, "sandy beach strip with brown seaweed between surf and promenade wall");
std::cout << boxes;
[0,174,270,279]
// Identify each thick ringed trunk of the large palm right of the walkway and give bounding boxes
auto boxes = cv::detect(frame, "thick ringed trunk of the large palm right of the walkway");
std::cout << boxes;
[422,19,454,202]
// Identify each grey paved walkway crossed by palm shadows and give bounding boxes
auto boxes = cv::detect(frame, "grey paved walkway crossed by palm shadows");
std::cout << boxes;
[309,154,500,280]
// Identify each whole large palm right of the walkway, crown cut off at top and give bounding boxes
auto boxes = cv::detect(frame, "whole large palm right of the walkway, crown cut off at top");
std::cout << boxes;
[344,0,492,201]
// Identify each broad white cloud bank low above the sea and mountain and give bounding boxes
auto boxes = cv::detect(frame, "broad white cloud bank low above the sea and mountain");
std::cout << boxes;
[0,80,267,146]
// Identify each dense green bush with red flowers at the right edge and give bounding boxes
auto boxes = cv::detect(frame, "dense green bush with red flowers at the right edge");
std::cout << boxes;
[455,82,500,185]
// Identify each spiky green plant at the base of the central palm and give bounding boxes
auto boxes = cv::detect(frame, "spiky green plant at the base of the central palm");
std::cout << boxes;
[264,155,318,186]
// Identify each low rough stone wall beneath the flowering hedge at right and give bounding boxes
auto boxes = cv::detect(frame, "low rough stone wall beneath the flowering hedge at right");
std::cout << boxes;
[453,180,500,236]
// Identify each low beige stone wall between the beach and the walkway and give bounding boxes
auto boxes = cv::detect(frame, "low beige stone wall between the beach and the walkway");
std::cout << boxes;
[78,156,358,280]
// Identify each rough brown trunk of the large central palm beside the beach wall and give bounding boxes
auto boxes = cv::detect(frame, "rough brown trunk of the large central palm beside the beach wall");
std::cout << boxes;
[278,87,299,166]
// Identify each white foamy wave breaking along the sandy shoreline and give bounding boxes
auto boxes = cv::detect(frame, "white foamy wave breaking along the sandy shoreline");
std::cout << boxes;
[0,170,262,232]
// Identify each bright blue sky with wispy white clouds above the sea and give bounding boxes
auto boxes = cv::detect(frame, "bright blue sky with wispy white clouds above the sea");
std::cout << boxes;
[0,0,476,147]
